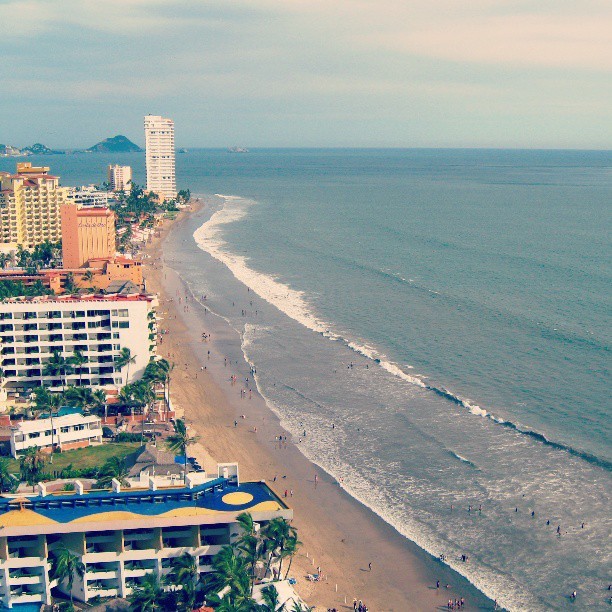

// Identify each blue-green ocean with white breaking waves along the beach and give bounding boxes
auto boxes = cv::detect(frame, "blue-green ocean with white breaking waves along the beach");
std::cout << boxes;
[0,149,612,610]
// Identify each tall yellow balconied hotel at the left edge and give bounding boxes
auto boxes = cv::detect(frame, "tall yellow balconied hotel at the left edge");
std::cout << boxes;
[0,162,68,249]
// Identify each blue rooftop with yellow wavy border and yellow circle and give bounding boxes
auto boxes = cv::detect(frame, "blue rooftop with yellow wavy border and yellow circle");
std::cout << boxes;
[0,478,287,528]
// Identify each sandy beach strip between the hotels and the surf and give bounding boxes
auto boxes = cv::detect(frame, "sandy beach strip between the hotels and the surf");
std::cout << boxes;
[145,202,493,612]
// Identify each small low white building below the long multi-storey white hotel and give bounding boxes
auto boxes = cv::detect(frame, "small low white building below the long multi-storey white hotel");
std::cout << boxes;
[10,412,102,457]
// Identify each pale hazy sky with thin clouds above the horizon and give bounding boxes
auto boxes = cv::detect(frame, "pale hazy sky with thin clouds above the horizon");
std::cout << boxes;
[0,0,612,149]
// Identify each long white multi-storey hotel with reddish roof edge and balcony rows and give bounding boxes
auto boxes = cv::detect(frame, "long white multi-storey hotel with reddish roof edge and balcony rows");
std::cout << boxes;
[0,294,157,397]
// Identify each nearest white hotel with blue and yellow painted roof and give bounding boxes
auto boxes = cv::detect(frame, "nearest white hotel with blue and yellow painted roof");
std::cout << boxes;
[0,464,293,608]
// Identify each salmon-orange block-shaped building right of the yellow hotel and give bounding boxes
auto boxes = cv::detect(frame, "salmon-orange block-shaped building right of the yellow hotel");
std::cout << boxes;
[61,204,115,268]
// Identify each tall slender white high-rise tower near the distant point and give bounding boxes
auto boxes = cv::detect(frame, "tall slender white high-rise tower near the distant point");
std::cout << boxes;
[144,115,176,200]
